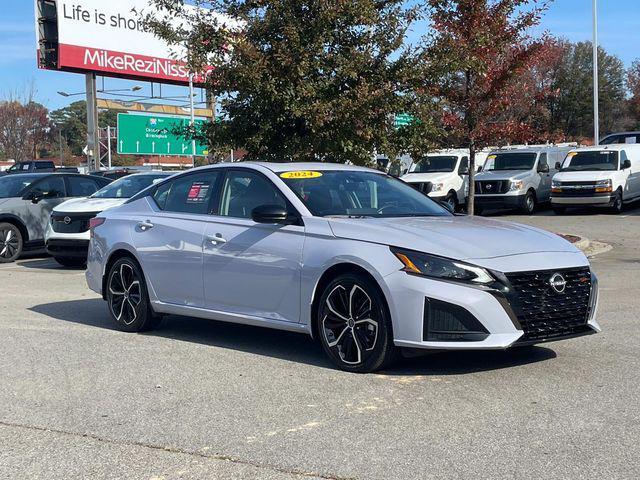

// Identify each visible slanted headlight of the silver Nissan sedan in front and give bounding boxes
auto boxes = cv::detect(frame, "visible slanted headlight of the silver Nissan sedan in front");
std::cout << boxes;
[391,248,495,285]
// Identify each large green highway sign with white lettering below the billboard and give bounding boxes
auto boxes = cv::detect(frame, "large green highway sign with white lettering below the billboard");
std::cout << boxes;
[118,113,209,156]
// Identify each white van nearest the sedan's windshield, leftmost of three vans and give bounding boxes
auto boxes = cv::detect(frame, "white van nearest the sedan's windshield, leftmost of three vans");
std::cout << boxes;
[402,149,482,211]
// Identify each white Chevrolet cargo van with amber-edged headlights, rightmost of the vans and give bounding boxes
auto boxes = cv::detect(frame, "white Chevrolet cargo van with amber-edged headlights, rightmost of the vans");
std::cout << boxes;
[551,144,640,215]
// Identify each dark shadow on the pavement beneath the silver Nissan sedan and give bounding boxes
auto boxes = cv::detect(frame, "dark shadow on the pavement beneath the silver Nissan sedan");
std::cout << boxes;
[30,298,556,376]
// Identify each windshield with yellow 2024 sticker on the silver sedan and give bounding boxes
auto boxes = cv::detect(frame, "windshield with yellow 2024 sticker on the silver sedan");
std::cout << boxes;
[280,170,450,217]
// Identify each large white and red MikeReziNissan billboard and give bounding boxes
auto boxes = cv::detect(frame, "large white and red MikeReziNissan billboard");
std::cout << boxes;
[36,0,233,84]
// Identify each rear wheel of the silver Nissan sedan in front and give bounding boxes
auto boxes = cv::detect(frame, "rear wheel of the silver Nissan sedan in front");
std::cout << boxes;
[106,258,160,332]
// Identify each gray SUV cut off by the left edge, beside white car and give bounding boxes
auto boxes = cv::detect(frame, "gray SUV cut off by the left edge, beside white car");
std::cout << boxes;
[0,173,110,263]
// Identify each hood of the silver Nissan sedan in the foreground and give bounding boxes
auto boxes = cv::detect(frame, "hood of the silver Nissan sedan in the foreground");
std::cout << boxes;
[329,216,579,260]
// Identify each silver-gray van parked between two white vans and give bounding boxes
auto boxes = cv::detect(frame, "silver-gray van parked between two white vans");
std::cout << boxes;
[475,143,577,214]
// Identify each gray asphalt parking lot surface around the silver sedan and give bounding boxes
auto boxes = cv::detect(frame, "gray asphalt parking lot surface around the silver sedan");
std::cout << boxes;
[0,207,640,479]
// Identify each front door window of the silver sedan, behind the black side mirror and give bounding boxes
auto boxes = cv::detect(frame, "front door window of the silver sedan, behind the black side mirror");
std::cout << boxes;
[220,170,287,218]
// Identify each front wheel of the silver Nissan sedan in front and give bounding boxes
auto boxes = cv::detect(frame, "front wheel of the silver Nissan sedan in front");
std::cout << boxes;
[316,274,397,373]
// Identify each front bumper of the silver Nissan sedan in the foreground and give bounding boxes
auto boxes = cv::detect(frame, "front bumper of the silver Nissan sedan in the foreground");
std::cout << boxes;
[385,267,600,350]
